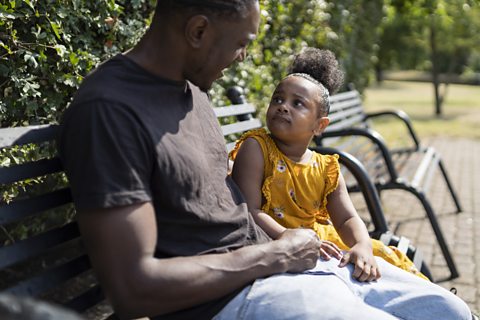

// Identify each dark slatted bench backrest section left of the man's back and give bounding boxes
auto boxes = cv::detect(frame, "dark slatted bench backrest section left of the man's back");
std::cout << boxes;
[0,125,104,312]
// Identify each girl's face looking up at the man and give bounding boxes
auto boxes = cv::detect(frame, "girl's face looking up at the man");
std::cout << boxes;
[267,76,329,142]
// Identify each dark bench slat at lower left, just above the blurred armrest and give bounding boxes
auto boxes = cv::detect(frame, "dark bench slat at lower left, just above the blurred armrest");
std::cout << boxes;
[5,255,91,296]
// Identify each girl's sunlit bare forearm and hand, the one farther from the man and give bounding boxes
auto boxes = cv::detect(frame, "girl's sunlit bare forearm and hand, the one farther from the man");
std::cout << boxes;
[327,173,380,281]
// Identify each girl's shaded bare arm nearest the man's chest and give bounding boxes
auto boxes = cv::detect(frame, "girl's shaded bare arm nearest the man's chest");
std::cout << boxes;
[232,138,286,239]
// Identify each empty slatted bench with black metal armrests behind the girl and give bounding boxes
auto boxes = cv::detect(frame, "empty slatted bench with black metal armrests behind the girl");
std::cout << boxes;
[315,90,462,279]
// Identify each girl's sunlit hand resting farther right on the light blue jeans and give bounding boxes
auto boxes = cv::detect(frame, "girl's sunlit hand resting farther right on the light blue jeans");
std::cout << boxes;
[338,243,381,282]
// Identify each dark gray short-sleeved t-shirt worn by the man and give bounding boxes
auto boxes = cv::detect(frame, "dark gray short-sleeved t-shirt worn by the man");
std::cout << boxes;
[59,55,269,319]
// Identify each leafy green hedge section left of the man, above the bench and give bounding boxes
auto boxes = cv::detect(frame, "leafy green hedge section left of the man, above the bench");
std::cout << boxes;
[0,0,154,126]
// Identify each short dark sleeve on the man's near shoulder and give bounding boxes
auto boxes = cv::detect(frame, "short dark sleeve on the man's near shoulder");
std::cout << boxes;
[58,101,154,211]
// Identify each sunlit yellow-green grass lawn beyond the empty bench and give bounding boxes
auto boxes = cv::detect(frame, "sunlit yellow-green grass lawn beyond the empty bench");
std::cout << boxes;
[364,80,480,141]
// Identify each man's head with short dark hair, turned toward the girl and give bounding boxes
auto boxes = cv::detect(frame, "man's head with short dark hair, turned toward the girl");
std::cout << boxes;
[154,0,260,91]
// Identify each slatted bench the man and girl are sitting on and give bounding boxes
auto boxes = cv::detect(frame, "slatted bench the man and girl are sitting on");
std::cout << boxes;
[0,90,436,319]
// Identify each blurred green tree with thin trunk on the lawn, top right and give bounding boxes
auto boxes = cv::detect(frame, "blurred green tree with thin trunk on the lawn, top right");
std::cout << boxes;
[377,0,480,116]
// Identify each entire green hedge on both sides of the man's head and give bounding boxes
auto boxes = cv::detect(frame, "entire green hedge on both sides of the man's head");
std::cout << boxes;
[0,0,383,127]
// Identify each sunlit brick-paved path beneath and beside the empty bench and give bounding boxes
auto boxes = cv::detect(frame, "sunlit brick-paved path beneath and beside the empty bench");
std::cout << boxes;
[354,138,480,312]
